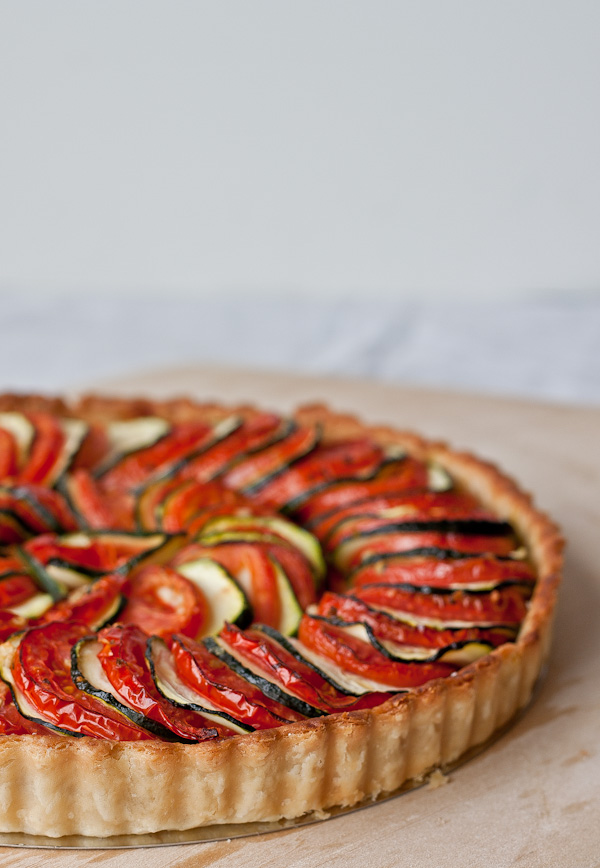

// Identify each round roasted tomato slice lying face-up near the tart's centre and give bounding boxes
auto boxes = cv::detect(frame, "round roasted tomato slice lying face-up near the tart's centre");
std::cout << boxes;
[120,564,208,637]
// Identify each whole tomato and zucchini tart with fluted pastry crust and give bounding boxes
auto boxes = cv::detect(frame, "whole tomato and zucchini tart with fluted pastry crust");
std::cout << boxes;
[0,396,562,837]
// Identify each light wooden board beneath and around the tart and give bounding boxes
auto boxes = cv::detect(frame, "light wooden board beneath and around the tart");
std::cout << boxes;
[0,369,600,868]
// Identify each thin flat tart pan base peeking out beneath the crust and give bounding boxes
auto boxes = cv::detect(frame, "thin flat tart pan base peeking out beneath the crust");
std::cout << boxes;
[0,688,544,850]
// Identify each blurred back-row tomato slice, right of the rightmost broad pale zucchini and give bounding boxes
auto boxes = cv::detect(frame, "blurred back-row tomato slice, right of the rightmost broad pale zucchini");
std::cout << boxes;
[101,422,213,491]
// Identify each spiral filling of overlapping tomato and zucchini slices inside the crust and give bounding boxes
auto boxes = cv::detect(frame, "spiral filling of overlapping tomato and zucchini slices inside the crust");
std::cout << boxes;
[0,411,536,743]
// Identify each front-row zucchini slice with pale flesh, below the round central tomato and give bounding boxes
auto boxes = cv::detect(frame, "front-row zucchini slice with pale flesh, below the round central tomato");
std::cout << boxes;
[146,636,254,735]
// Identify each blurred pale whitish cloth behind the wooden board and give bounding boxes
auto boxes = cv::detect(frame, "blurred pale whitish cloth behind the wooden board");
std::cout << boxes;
[0,293,600,404]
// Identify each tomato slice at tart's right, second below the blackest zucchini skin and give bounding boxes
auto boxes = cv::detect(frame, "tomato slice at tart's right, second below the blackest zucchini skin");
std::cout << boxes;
[350,549,535,588]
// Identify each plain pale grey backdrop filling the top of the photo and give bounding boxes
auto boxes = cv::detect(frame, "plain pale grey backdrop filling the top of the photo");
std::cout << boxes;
[0,0,600,299]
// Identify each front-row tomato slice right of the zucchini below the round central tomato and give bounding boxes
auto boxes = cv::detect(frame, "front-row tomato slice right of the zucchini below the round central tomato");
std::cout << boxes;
[171,636,304,729]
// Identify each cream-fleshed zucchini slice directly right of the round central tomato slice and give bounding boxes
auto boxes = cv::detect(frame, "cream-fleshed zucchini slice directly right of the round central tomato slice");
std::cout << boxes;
[177,558,252,636]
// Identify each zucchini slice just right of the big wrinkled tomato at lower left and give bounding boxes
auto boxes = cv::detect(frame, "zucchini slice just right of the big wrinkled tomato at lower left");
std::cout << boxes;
[71,636,184,744]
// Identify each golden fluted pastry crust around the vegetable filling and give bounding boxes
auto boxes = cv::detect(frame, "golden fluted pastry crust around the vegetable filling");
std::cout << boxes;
[0,395,563,837]
